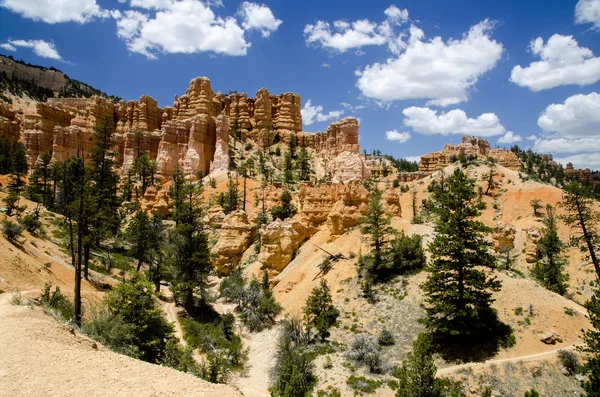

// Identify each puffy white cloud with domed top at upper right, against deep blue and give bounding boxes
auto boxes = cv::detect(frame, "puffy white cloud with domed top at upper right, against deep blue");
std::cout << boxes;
[510,34,600,91]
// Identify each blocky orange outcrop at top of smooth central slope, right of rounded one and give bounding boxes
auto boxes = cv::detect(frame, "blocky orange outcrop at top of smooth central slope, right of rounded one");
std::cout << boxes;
[258,218,315,273]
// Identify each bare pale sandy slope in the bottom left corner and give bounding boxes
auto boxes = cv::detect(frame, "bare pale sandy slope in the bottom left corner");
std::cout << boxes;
[0,294,240,397]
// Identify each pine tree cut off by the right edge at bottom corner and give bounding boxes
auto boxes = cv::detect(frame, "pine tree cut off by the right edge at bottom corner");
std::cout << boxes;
[577,289,600,397]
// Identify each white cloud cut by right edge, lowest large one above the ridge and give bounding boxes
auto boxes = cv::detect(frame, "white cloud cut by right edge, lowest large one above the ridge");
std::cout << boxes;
[538,92,600,138]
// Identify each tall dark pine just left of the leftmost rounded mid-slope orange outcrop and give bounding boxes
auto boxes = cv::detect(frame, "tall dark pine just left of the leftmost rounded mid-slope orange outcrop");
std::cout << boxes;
[169,182,212,313]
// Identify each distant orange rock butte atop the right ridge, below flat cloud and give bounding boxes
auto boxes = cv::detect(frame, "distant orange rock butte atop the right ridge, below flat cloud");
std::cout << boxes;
[419,136,521,172]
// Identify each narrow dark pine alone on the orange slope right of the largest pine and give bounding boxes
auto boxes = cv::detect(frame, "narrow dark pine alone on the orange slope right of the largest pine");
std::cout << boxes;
[532,204,568,295]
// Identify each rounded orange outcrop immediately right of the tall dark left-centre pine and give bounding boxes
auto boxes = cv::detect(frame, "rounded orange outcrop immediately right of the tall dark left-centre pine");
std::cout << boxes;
[211,211,256,274]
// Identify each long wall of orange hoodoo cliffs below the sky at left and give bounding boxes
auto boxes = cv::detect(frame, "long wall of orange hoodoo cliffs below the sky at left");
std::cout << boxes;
[16,77,369,181]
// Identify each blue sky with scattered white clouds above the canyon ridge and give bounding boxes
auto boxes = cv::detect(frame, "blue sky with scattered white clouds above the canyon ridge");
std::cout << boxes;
[0,0,600,169]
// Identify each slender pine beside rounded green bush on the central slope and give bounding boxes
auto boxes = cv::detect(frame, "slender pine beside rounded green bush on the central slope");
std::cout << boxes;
[360,189,394,269]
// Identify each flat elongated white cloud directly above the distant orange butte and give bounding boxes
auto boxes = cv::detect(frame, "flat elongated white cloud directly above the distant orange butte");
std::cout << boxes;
[402,106,505,137]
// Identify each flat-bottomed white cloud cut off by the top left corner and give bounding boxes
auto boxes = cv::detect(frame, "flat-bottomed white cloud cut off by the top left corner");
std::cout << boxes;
[0,0,109,24]
